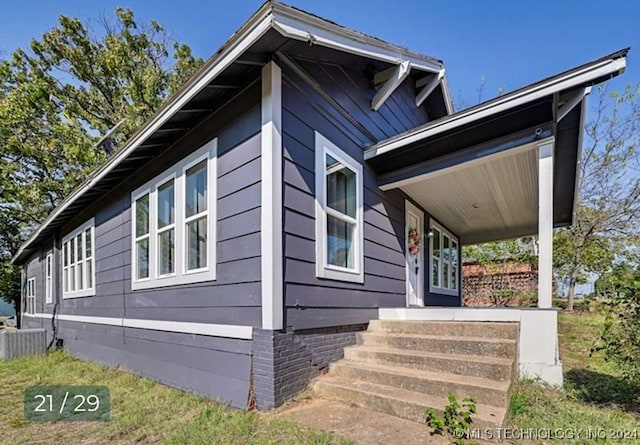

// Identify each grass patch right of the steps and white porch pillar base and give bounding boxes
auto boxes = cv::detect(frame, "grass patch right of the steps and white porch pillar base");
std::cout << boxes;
[509,313,640,444]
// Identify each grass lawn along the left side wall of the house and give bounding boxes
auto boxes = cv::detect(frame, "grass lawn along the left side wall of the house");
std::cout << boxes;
[0,352,350,445]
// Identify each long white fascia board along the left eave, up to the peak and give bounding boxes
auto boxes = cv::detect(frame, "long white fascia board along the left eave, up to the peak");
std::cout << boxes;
[11,8,271,262]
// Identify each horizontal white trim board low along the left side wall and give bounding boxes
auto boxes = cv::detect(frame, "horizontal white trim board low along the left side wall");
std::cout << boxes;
[23,313,253,340]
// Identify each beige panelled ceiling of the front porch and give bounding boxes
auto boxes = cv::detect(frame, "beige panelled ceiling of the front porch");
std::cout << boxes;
[400,143,538,244]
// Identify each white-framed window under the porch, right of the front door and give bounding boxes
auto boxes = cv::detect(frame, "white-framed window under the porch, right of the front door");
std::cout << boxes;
[429,220,460,295]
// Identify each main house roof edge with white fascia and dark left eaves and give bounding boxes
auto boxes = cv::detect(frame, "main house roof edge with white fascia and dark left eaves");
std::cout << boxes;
[11,1,453,263]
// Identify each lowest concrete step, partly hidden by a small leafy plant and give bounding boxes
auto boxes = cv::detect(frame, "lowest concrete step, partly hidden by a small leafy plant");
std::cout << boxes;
[313,375,506,428]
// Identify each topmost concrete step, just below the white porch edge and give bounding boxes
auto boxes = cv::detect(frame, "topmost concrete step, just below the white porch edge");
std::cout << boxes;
[369,320,518,340]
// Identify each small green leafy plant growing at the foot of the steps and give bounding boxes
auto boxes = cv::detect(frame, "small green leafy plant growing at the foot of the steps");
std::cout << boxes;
[425,393,477,445]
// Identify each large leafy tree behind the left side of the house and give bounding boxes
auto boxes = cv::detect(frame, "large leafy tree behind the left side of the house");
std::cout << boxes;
[0,8,202,312]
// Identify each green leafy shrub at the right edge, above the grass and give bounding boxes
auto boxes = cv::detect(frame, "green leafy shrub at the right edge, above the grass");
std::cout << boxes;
[595,262,640,384]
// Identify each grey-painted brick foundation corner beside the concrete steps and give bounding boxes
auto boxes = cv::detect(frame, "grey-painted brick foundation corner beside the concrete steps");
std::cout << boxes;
[252,324,367,409]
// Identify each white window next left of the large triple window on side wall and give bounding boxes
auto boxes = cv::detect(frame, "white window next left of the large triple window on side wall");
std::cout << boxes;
[62,218,96,298]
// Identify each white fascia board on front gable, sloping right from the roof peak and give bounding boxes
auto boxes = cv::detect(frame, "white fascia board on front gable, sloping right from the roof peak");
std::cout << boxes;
[273,11,442,73]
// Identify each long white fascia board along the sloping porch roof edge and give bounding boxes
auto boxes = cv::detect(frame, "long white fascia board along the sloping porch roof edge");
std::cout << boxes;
[364,58,626,160]
